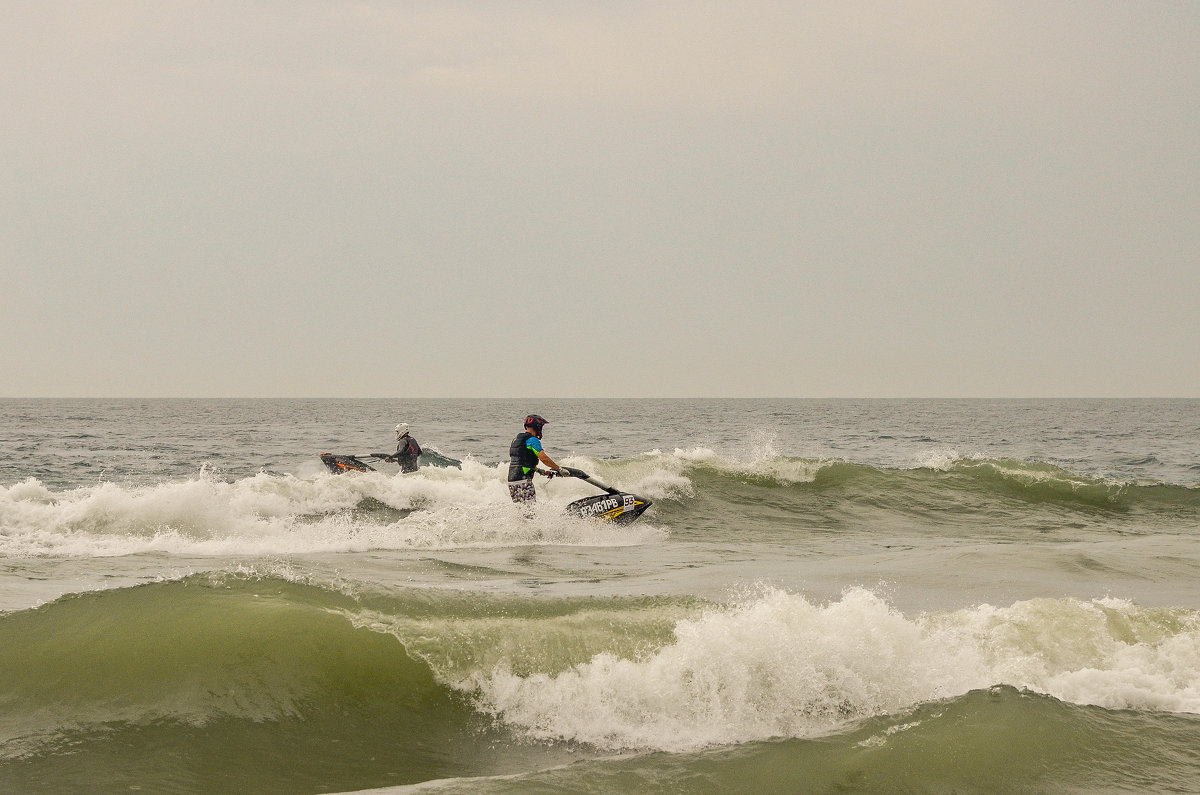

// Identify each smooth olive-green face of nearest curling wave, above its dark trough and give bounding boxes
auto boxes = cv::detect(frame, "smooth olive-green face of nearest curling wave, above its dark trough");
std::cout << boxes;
[0,575,442,740]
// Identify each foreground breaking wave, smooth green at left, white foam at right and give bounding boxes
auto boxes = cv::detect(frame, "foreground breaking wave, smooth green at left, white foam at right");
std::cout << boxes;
[0,572,1200,770]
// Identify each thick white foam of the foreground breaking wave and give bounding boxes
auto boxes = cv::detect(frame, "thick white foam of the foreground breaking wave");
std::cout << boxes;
[474,588,1200,752]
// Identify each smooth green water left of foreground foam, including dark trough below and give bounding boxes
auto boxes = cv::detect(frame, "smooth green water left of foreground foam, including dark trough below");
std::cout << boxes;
[0,574,585,793]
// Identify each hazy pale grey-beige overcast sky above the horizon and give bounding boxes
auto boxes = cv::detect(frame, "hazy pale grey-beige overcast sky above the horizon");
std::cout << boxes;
[0,0,1200,398]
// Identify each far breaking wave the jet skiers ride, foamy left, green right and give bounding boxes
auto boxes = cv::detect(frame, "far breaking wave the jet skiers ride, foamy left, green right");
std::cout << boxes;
[0,449,1200,556]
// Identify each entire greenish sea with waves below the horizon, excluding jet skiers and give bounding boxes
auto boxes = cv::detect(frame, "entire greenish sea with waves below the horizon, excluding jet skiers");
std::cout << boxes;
[0,399,1200,794]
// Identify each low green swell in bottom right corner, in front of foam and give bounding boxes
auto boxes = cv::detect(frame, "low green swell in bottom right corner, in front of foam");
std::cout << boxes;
[420,686,1200,795]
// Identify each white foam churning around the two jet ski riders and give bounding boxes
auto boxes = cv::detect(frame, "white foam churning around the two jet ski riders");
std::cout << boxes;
[0,461,673,557]
